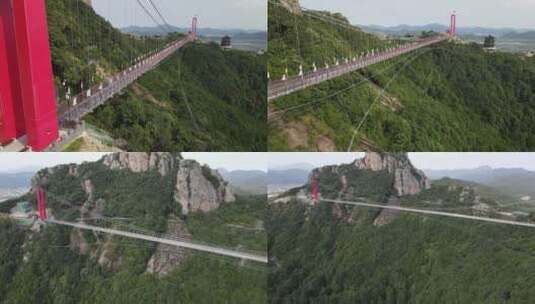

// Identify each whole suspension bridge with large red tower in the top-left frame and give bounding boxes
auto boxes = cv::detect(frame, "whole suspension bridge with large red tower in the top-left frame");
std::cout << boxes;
[0,0,198,152]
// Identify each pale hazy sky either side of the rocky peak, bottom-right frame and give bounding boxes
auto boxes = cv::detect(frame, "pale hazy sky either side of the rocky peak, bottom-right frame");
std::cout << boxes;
[269,153,535,171]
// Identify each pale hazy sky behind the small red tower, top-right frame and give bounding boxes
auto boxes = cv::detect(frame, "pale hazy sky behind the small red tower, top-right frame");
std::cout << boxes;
[301,0,535,28]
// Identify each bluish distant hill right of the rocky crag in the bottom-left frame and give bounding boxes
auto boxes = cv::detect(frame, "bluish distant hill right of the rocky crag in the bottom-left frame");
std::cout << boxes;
[217,169,267,194]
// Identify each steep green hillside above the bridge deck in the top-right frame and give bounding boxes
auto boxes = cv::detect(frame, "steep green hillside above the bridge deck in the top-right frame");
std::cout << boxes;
[268,0,386,79]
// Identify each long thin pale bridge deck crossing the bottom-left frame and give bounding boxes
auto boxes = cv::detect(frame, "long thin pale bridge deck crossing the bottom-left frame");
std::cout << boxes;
[46,219,268,263]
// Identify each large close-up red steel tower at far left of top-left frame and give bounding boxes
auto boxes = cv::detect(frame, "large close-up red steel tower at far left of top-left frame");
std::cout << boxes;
[0,0,59,151]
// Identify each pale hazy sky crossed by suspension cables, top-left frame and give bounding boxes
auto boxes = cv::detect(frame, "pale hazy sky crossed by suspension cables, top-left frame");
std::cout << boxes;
[93,0,267,30]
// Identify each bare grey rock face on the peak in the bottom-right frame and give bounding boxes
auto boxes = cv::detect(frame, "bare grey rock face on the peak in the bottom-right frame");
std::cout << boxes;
[354,152,431,196]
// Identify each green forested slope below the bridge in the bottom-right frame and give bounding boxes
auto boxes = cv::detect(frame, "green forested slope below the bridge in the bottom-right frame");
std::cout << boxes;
[268,204,535,303]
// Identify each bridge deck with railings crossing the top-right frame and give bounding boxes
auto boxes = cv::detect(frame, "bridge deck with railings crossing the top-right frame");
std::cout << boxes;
[268,35,450,101]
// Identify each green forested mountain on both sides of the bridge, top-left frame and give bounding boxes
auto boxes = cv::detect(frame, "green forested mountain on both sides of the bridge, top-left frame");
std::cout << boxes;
[47,0,267,151]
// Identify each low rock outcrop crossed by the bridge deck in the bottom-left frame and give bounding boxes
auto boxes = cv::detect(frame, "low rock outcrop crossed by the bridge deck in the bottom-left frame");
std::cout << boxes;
[147,217,191,277]
